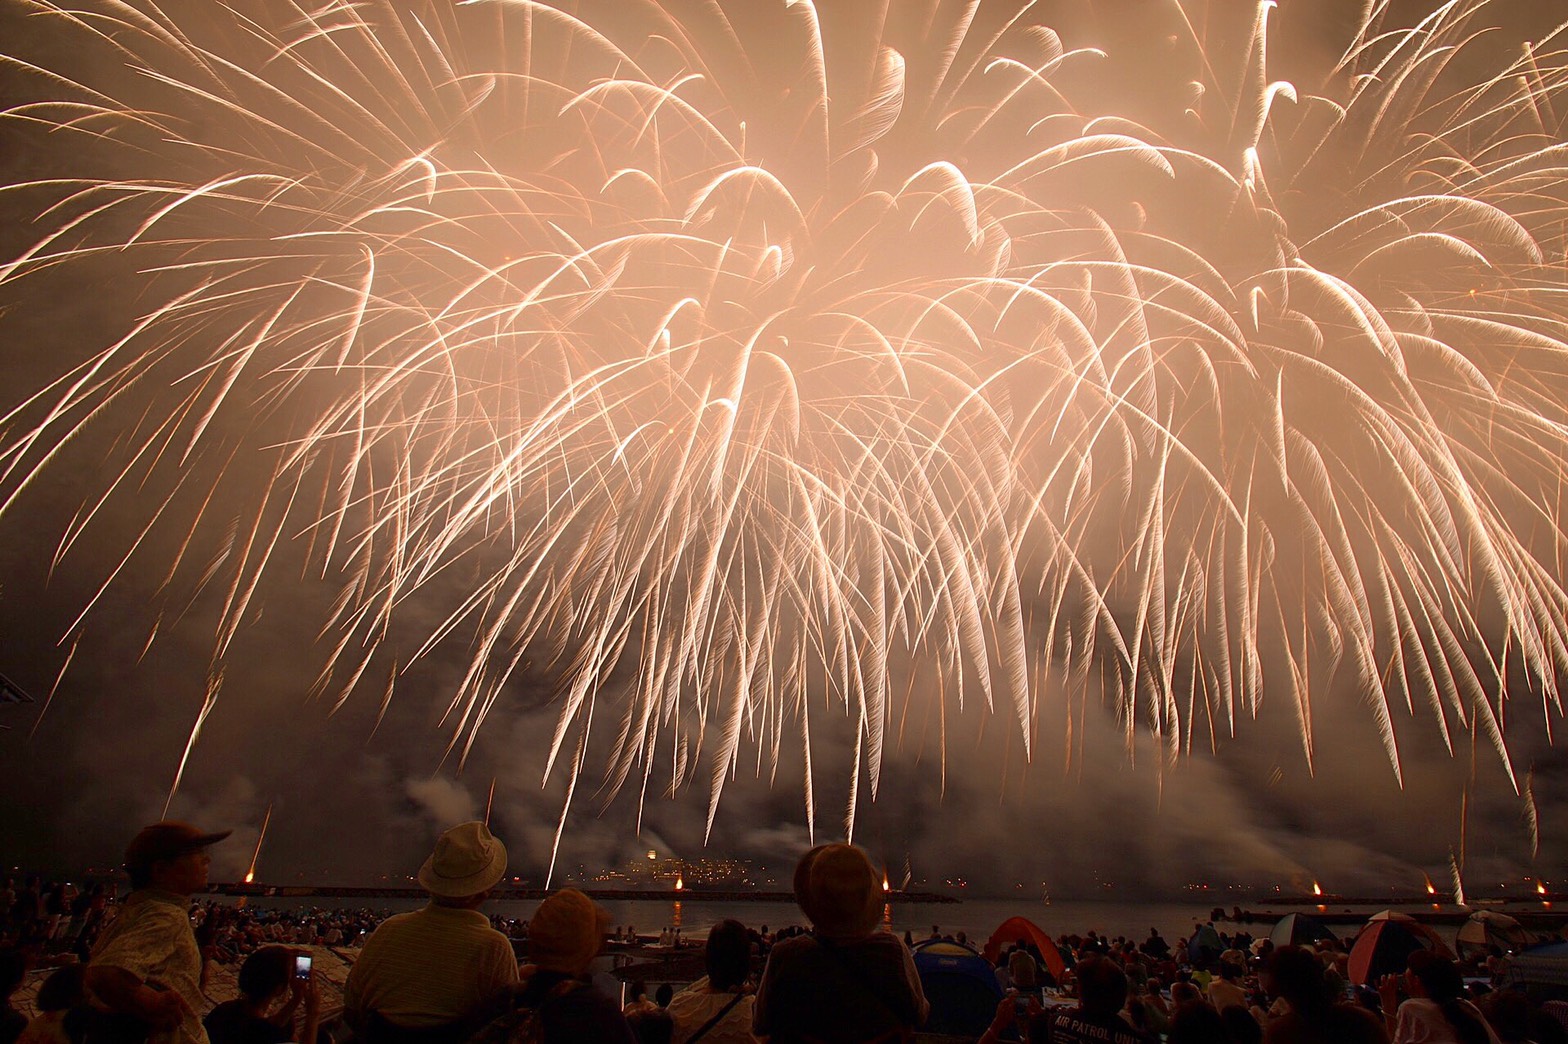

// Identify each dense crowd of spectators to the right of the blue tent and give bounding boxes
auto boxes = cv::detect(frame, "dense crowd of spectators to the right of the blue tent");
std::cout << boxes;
[982,923,1568,1044]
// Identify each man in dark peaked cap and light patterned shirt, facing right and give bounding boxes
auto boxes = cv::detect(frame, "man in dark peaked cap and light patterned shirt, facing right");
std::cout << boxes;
[86,820,229,1044]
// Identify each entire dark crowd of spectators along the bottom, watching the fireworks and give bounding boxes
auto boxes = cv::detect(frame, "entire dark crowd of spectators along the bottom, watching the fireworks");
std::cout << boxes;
[0,823,1568,1044]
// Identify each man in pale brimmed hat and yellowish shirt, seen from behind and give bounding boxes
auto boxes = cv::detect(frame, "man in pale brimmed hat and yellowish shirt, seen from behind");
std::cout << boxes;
[343,823,517,1044]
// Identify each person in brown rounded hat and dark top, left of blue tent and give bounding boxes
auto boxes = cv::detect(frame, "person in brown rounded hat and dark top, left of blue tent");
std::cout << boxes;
[751,845,930,1044]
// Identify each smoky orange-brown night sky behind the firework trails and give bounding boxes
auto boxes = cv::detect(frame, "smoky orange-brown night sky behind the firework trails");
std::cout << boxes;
[0,0,1568,898]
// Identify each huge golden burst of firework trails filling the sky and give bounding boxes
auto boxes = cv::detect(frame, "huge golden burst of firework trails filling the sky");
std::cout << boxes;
[0,0,1568,831]
